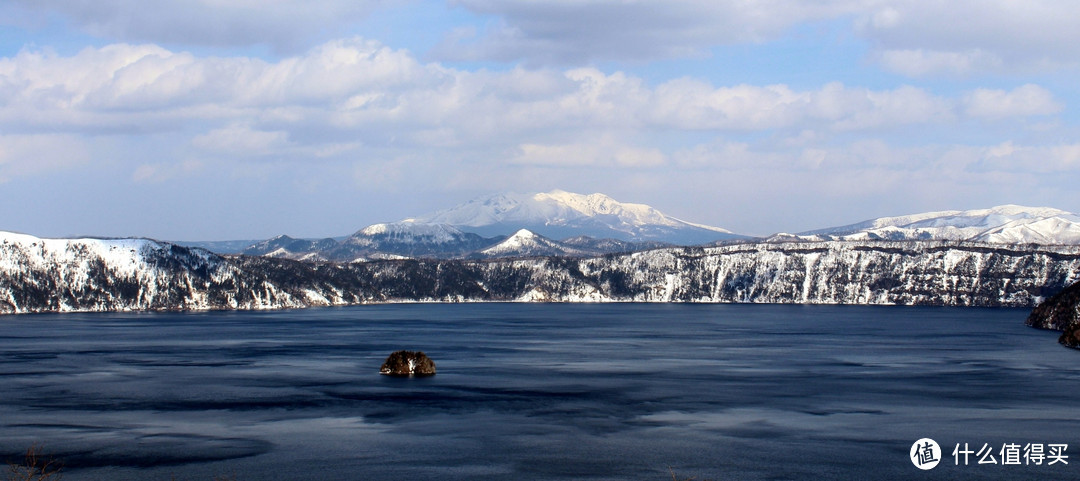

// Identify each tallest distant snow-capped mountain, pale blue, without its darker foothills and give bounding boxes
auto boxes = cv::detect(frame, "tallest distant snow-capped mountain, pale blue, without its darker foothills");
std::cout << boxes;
[406,190,741,245]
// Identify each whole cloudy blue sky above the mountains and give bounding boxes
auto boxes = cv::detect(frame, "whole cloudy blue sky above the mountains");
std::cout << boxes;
[0,0,1080,241]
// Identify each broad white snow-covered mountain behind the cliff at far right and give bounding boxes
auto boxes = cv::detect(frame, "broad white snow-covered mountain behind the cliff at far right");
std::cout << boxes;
[790,205,1080,244]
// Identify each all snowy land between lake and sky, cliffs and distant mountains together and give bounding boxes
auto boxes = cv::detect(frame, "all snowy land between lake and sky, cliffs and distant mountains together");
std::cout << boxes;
[6,192,1080,347]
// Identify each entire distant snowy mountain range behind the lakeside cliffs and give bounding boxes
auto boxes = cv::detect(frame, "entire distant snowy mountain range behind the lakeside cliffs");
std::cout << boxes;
[208,190,1080,262]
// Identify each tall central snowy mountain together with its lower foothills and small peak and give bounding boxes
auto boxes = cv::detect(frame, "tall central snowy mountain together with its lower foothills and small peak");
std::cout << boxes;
[225,190,725,262]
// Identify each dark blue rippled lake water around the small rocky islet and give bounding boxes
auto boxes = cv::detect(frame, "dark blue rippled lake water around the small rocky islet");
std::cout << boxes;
[0,304,1080,481]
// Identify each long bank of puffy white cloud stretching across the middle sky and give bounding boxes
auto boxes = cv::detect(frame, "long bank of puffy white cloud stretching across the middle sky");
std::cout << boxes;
[0,39,1028,146]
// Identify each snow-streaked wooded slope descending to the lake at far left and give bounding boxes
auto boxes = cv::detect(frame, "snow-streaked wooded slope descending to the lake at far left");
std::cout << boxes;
[0,232,360,313]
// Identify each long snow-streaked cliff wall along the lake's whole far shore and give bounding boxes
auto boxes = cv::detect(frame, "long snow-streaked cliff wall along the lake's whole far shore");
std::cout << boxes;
[0,236,1080,313]
